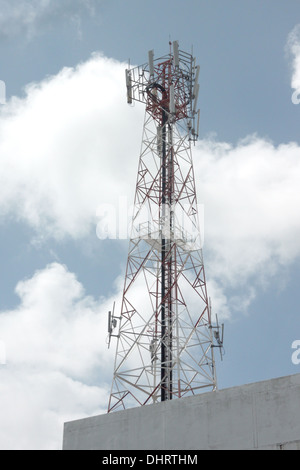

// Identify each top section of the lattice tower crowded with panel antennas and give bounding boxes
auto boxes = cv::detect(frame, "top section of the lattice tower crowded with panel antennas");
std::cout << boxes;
[126,41,200,141]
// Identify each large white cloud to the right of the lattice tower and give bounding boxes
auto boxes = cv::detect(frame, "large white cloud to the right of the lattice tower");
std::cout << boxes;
[194,136,300,296]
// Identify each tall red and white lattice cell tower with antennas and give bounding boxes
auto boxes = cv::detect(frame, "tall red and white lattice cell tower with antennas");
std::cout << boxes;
[108,41,223,412]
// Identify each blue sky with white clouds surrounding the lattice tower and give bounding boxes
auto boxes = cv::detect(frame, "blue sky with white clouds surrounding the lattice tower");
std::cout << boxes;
[0,0,300,449]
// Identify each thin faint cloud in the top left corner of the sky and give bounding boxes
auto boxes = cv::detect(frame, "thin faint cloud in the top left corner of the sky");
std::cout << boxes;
[0,0,95,38]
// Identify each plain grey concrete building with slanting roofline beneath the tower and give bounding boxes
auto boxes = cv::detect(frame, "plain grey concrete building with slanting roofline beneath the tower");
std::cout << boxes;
[63,374,300,450]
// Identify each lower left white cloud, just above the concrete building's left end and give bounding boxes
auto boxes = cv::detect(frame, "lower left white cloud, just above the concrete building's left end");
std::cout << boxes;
[0,263,113,449]
